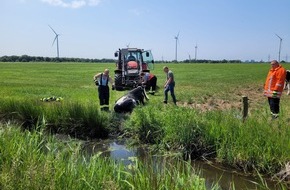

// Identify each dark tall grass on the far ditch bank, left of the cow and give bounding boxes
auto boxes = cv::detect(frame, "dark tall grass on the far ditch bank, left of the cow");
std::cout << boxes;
[0,100,114,139]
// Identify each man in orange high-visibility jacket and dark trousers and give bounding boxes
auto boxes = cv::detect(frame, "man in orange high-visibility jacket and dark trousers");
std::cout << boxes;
[264,60,286,118]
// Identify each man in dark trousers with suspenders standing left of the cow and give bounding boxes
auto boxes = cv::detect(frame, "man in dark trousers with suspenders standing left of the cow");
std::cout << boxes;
[94,69,115,111]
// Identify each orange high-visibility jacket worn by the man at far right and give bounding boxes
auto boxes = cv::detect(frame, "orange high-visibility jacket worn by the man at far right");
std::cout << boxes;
[264,65,286,98]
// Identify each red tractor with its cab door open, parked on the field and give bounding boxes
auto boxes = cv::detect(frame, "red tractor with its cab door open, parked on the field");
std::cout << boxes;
[115,48,154,90]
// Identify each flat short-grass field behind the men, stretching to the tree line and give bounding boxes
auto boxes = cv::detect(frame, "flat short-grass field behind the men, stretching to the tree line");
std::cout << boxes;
[0,63,287,109]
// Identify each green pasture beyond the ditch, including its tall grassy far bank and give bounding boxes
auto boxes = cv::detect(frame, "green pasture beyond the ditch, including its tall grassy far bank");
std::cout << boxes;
[0,63,290,189]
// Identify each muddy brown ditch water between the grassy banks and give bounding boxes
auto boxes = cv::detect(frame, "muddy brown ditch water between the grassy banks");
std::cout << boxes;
[84,140,278,190]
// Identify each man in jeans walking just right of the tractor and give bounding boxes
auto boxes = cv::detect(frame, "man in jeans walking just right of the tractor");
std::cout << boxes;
[163,66,176,105]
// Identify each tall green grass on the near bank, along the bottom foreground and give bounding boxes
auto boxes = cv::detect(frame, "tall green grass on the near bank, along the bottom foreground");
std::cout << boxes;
[0,125,218,190]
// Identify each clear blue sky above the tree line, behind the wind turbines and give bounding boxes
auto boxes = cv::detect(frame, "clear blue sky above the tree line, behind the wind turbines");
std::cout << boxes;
[0,0,290,61]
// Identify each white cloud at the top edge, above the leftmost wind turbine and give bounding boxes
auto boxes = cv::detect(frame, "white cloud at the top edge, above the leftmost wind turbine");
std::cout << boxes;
[41,0,101,9]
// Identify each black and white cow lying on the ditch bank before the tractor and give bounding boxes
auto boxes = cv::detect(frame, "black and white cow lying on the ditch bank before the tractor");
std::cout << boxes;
[114,86,149,113]
